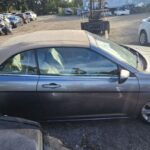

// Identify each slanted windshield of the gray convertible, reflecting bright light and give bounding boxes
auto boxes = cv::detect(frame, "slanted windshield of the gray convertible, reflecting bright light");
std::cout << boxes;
[90,34,138,69]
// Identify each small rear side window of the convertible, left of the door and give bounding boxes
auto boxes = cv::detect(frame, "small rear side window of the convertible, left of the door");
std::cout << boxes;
[0,50,37,75]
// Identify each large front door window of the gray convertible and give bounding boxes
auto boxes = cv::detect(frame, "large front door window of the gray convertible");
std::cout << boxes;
[37,48,118,76]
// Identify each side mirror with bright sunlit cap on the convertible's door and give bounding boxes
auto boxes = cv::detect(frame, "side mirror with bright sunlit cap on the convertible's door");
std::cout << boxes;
[119,69,130,83]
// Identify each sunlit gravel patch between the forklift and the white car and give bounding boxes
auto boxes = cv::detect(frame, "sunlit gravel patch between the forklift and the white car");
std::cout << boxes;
[108,13,150,45]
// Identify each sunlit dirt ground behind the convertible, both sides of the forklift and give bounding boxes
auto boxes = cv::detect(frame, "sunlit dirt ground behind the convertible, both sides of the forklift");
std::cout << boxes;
[0,13,150,44]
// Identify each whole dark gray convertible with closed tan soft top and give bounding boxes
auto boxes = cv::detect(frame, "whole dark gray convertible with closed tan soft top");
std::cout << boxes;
[0,30,150,122]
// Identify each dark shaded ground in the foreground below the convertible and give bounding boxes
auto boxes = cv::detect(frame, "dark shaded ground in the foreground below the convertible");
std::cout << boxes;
[44,119,150,150]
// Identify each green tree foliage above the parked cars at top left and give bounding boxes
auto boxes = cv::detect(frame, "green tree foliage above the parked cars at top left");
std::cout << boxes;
[0,0,82,14]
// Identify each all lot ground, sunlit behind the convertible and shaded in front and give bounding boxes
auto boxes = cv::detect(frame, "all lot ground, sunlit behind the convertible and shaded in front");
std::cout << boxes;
[0,14,150,150]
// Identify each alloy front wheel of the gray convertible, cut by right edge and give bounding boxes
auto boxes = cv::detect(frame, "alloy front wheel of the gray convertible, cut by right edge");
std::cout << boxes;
[142,103,150,123]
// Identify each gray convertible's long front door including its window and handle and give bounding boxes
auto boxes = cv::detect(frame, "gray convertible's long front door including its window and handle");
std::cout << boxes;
[37,48,139,119]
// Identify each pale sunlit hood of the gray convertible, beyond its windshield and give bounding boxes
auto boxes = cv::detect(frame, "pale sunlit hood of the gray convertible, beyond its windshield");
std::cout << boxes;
[125,45,150,73]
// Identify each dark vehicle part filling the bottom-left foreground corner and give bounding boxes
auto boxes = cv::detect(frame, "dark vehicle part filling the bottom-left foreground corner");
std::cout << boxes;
[0,117,43,150]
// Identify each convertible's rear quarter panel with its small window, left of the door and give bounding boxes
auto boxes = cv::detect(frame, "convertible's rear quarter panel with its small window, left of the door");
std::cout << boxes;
[0,50,39,119]
